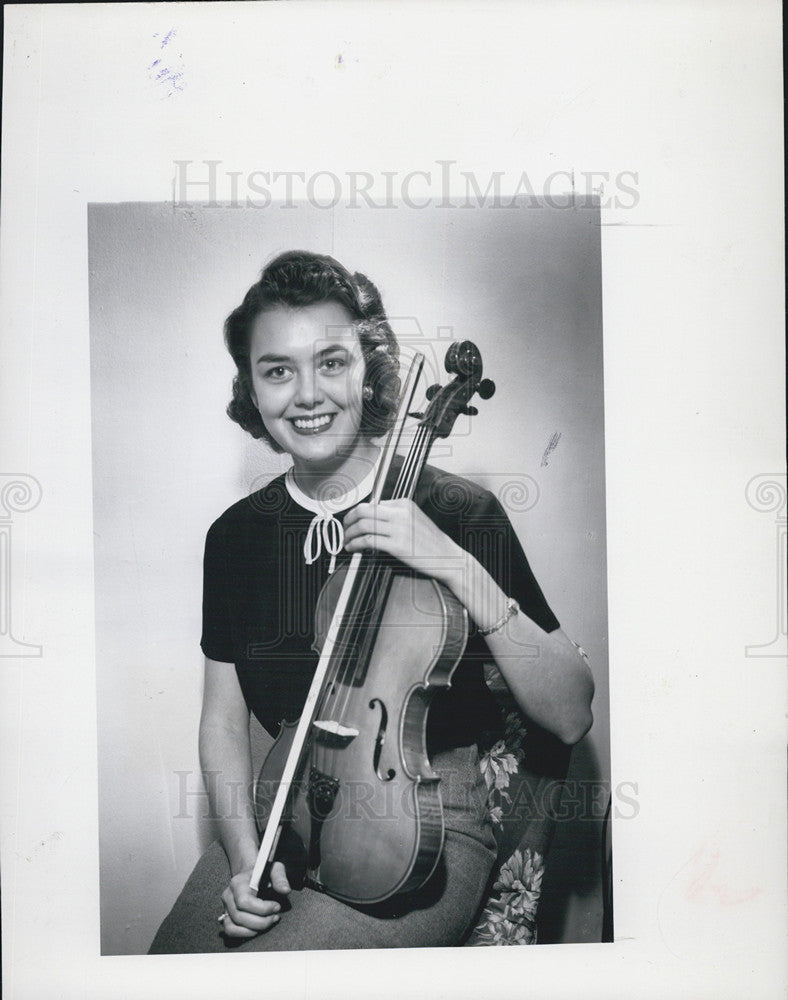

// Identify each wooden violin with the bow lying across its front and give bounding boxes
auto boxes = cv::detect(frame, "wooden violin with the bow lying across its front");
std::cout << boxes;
[250,341,495,904]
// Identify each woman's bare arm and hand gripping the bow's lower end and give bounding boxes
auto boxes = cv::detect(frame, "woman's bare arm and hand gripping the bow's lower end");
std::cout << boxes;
[200,657,290,938]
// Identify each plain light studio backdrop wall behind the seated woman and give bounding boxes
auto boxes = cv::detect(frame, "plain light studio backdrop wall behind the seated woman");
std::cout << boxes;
[88,195,610,954]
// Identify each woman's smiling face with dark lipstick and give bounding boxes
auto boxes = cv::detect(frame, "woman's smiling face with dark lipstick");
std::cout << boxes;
[249,302,364,469]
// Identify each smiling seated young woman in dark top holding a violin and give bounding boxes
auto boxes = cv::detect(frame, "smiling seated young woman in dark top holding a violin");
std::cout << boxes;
[151,252,593,953]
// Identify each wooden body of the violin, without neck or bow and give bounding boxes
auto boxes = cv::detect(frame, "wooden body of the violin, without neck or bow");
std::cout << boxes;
[255,568,468,904]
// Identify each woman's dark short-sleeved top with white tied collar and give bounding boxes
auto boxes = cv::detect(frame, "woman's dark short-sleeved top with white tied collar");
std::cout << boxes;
[201,466,558,751]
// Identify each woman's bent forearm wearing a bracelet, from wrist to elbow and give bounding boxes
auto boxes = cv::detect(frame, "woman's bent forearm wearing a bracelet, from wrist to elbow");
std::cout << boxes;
[443,546,594,744]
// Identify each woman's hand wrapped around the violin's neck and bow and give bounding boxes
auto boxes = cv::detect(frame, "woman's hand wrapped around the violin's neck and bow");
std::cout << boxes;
[343,500,464,580]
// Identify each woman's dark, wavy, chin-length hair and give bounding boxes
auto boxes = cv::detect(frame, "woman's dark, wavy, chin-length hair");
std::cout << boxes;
[224,250,400,452]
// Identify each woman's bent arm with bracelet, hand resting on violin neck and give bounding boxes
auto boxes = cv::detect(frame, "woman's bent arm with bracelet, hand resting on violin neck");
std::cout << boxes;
[344,500,594,744]
